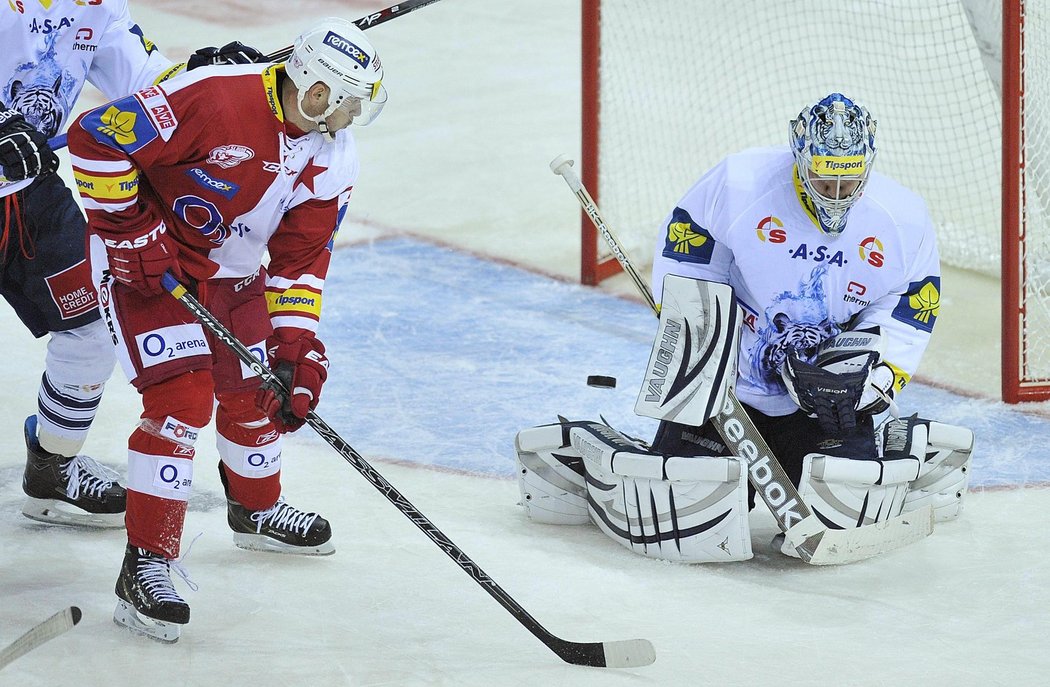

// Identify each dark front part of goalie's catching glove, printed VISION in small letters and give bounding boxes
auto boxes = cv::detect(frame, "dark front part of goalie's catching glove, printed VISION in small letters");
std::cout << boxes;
[780,351,877,437]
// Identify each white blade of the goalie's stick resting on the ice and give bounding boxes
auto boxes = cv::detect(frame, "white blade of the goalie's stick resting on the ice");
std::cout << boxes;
[784,505,933,565]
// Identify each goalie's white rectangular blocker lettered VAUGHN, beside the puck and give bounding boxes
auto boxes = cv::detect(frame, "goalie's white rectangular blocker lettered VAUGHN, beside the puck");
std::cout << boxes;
[634,274,740,426]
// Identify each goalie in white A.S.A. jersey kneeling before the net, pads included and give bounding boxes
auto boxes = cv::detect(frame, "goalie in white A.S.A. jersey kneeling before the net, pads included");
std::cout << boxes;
[516,93,973,562]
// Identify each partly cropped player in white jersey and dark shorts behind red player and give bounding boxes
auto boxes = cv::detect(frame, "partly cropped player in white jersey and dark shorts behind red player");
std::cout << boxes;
[0,0,261,527]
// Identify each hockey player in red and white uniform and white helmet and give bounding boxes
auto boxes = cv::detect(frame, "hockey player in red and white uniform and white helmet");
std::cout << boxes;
[69,19,386,641]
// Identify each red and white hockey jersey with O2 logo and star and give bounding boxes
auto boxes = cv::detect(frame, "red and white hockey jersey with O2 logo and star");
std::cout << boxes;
[69,64,358,331]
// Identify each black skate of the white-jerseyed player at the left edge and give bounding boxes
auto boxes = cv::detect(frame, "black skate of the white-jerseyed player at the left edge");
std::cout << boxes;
[22,415,127,527]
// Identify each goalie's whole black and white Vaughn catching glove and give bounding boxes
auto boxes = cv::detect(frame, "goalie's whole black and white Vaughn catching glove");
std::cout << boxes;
[780,327,894,435]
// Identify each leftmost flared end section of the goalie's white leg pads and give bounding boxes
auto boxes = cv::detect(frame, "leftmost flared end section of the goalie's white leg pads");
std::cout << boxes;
[515,422,590,525]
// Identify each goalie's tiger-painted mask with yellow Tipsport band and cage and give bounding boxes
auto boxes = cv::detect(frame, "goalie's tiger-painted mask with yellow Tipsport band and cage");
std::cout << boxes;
[790,93,876,236]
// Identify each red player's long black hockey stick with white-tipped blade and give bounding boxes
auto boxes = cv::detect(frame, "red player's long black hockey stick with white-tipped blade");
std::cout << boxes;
[161,272,656,668]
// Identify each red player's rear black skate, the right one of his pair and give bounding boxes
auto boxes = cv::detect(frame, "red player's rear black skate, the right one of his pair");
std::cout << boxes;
[218,463,335,556]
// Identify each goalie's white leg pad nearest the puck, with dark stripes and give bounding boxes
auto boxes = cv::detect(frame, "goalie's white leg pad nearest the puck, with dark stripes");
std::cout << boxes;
[517,422,752,563]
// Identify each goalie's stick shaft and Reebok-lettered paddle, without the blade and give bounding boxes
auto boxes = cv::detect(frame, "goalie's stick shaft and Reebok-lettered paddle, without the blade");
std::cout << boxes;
[550,155,822,562]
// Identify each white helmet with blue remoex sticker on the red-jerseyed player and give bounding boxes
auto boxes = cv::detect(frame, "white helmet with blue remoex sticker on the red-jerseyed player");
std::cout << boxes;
[285,17,386,138]
